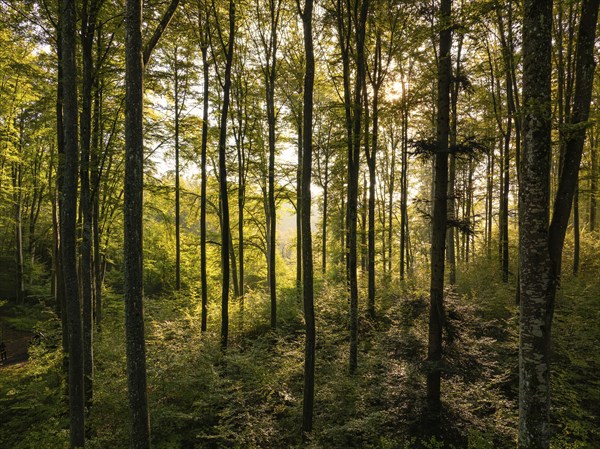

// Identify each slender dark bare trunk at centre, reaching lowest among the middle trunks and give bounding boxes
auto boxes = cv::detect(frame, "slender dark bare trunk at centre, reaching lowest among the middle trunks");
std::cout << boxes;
[301,0,315,434]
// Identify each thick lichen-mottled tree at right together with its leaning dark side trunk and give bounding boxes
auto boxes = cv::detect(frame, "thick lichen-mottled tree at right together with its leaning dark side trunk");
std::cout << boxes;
[519,0,600,448]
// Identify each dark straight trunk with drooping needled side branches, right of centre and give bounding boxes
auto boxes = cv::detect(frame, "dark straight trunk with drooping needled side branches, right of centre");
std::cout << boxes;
[427,0,452,427]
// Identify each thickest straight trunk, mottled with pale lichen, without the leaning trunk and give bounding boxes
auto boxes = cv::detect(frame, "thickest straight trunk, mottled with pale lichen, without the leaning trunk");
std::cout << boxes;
[519,0,554,449]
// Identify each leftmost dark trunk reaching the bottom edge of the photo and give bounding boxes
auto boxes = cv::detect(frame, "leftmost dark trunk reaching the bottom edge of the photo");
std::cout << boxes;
[60,0,85,442]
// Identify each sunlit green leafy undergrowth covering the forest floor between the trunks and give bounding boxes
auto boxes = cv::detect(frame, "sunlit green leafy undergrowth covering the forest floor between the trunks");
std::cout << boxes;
[0,254,600,449]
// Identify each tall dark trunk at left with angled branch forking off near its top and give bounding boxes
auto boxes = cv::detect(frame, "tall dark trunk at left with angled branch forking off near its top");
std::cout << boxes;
[122,0,179,442]
